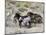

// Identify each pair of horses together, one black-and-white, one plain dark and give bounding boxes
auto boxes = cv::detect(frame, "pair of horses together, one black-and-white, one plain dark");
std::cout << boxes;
[14,12,42,28]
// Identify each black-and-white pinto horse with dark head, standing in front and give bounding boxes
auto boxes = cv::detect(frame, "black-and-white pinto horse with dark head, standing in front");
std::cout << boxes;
[14,13,31,28]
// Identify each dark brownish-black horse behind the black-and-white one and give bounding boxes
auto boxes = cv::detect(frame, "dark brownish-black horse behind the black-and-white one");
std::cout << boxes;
[27,12,42,23]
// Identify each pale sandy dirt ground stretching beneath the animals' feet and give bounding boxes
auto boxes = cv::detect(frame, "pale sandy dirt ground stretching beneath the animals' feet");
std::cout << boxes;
[6,23,44,34]
